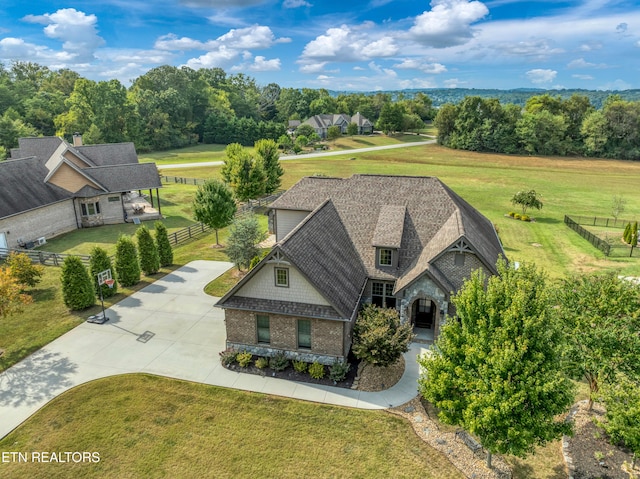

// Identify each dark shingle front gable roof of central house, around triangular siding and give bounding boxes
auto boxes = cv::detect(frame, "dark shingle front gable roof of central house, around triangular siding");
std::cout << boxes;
[217,201,367,320]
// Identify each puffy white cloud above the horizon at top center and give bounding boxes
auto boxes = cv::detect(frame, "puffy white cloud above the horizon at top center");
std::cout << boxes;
[300,23,398,64]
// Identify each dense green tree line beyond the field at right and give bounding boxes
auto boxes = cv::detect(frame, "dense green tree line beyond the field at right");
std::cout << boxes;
[435,94,640,160]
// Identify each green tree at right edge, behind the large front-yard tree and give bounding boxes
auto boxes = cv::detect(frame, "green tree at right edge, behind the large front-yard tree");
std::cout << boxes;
[555,273,640,405]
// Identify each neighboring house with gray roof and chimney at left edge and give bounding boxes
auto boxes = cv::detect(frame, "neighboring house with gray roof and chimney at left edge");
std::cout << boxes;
[0,135,162,248]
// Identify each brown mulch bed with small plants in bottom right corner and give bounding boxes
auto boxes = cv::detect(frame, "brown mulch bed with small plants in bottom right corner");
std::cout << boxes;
[567,401,640,479]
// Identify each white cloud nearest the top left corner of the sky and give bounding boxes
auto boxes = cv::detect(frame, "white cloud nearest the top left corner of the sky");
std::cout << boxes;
[23,8,104,62]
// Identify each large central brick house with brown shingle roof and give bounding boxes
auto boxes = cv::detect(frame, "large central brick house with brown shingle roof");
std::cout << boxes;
[216,175,504,364]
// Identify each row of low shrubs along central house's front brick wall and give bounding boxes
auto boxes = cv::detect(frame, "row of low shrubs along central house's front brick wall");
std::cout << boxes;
[220,348,351,382]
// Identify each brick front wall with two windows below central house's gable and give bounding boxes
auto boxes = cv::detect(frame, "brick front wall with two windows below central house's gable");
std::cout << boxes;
[225,309,350,365]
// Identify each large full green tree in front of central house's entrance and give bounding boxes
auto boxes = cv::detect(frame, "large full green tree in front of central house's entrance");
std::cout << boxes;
[419,260,574,465]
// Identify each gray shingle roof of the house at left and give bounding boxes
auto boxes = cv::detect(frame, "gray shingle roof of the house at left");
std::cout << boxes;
[0,137,161,218]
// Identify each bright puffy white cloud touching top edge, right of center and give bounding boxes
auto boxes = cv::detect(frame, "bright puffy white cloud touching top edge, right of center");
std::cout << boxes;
[409,0,489,48]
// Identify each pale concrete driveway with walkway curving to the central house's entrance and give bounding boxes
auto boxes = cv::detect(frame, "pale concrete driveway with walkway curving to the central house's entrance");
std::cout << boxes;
[0,261,425,438]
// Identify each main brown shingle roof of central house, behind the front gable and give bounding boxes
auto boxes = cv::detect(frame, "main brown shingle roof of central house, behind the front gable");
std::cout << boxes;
[270,175,503,284]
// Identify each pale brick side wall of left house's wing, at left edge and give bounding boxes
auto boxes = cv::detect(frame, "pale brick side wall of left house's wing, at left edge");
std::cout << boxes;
[0,199,80,248]
